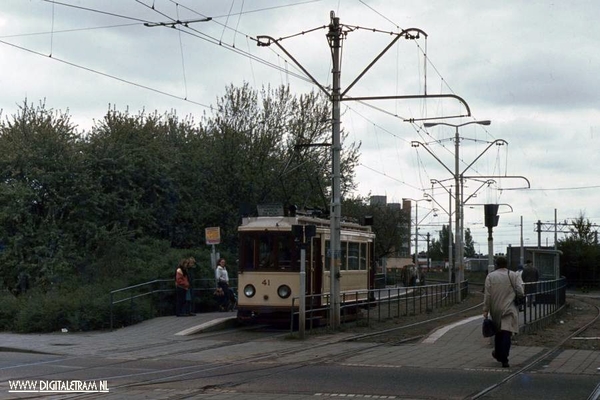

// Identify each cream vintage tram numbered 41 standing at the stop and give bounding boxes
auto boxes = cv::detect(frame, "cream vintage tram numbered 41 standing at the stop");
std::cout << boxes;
[237,216,375,322]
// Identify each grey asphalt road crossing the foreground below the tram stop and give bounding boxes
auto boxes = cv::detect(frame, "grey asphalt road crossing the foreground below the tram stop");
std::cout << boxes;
[0,342,599,400]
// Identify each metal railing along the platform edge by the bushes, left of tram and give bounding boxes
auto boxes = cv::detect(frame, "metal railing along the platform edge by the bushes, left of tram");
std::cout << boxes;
[110,279,237,331]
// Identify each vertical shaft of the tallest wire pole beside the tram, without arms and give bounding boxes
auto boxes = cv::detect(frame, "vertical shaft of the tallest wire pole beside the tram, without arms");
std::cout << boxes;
[328,11,342,329]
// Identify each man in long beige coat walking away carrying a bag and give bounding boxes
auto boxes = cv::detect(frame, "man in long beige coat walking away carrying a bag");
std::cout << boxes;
[483,257,523,368]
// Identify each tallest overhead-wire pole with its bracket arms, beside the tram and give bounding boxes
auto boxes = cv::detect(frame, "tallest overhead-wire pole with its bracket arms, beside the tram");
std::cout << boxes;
[256,11,471,329]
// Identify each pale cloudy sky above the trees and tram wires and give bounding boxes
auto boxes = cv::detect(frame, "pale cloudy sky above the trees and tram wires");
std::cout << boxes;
[0,0,600,254]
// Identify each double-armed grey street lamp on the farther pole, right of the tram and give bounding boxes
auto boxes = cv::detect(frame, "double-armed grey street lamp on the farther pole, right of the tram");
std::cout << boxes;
[423,120,492,301]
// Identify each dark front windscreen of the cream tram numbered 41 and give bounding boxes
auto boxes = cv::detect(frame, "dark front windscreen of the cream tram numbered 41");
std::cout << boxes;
[240,232,300,271]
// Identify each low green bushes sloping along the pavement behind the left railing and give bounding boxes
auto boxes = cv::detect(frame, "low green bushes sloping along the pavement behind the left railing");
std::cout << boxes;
[0,240,237,333]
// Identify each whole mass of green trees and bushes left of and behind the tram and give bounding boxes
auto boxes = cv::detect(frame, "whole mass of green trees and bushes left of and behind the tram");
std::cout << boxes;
[0,85,360,332]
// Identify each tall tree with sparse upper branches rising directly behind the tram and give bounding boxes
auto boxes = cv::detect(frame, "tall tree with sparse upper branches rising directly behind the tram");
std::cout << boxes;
[200,84,360,247]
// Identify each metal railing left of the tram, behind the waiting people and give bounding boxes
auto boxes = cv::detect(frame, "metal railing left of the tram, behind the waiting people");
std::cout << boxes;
[110,279,237,330]
